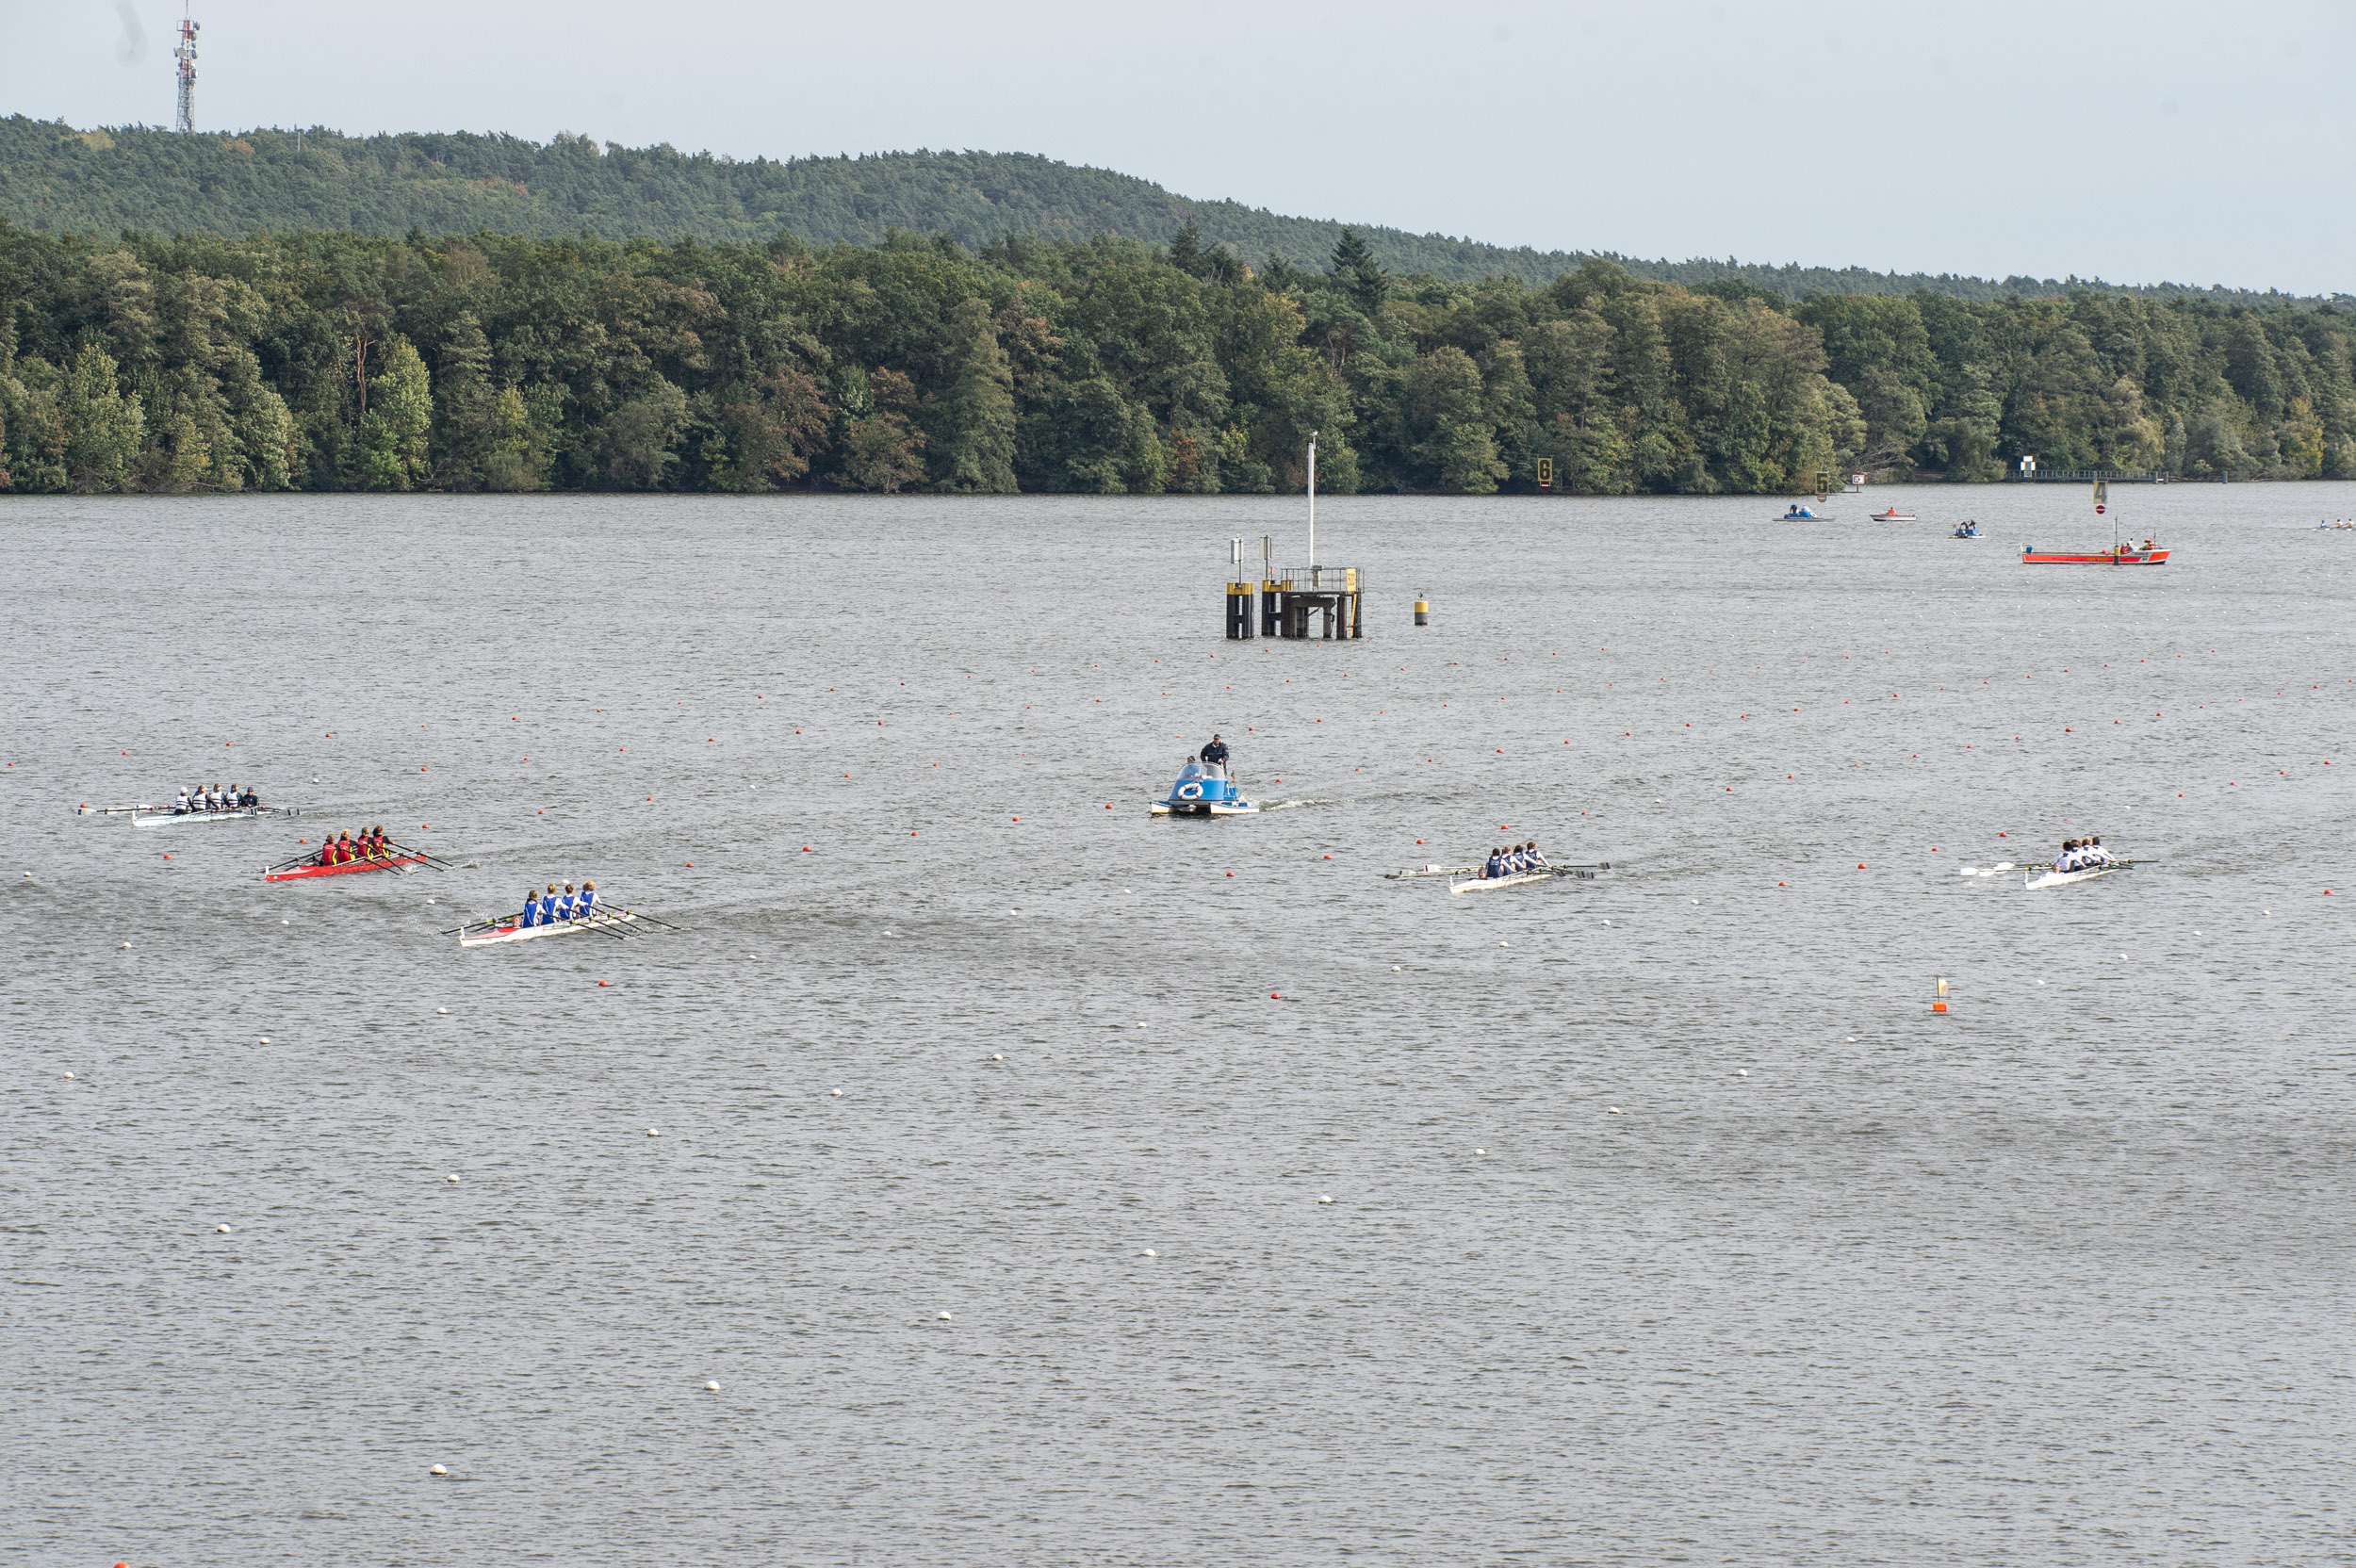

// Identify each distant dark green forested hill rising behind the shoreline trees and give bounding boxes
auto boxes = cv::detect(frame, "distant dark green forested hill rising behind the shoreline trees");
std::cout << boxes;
[0,115,2318,303]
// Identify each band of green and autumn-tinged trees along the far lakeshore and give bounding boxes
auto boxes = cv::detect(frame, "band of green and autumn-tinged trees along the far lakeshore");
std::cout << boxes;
[0,223,2356,495]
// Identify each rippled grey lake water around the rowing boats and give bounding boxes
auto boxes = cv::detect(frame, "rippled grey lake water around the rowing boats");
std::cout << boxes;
[0,485,2356,1566]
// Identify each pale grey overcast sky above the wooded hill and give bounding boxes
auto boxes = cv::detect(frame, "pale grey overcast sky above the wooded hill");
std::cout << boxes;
[0,0,2356,294]
